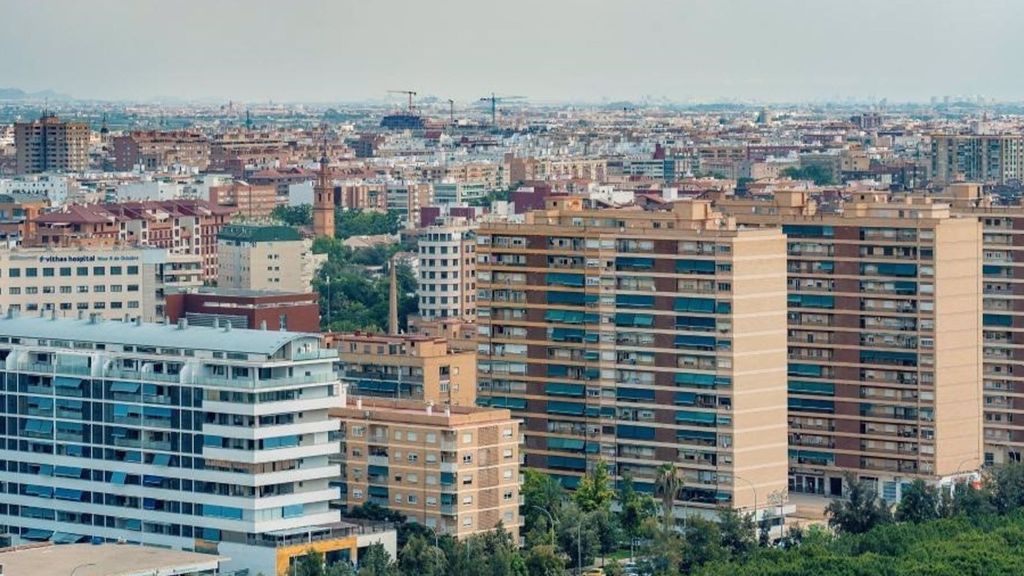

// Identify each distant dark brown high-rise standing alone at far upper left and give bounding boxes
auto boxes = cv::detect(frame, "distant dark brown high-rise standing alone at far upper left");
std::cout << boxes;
[14,115,89,174]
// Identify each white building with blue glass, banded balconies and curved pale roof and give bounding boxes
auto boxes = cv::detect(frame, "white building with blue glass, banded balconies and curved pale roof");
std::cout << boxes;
[0,317,358,575]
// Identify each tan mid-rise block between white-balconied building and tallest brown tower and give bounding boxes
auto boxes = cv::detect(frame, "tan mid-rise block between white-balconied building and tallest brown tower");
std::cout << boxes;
[330,398,519,538]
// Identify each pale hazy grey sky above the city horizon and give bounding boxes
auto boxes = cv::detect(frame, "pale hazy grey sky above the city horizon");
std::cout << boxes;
[0,0,1024,104]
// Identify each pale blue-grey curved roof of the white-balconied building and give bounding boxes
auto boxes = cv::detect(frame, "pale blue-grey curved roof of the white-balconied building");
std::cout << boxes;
[0,316,319,356]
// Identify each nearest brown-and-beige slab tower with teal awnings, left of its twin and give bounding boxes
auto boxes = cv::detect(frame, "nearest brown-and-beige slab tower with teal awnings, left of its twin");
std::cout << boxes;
[477,197,786,512]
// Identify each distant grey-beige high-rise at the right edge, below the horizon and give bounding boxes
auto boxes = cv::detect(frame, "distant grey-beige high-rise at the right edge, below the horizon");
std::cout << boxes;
[932,134,1024,184]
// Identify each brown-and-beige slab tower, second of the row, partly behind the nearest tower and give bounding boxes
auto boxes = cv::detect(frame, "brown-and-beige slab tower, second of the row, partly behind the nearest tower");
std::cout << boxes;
[718,192,982,501]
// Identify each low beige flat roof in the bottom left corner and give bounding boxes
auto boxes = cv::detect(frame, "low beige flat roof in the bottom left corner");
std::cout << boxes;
[0,544,230,576]
